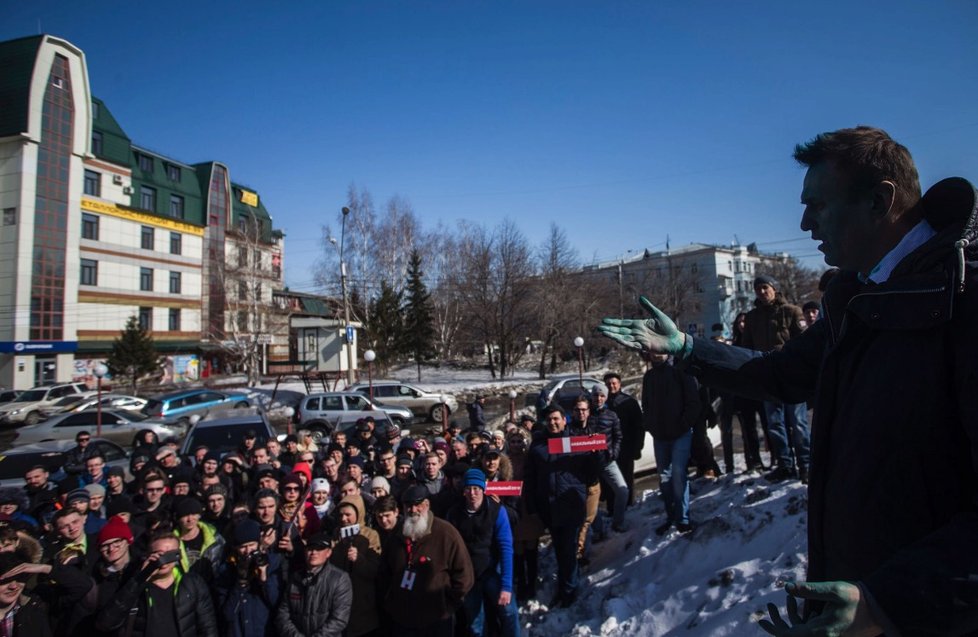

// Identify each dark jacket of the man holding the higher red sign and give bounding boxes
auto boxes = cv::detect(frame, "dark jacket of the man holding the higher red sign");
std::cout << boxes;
[523,429,600,530]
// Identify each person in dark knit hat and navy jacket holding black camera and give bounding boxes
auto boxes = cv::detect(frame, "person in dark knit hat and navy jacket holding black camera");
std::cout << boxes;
[214,518,282,637]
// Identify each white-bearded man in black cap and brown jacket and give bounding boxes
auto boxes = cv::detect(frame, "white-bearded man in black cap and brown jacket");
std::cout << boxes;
[379,485,474,637]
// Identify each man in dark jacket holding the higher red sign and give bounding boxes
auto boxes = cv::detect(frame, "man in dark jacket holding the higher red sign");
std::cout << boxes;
[523,404,599,608]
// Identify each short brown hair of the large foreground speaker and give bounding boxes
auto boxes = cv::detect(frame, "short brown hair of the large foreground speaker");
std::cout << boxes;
[794,126,920,212]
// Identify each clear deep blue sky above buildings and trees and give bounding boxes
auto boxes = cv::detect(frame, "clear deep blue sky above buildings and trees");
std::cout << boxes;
[0,0,978,290]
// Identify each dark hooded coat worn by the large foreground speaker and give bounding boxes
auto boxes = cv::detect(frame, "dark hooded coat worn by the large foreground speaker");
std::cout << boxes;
[686,179,978,635]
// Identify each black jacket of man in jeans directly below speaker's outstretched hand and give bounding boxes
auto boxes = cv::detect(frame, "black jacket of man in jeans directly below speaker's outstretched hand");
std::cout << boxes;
[642,363,703,441]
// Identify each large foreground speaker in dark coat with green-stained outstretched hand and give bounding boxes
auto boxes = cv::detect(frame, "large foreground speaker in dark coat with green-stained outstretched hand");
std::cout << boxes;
[601,126,978,635]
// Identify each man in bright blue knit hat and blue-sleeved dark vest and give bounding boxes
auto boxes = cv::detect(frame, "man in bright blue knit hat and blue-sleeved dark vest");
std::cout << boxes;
[447,469,520,637]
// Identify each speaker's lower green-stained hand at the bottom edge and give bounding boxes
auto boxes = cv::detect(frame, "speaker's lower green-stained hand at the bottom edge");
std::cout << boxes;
[758,582,883,637]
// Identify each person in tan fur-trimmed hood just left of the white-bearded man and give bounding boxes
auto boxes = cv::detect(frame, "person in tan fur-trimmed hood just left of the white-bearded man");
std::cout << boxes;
[329,496,380,637]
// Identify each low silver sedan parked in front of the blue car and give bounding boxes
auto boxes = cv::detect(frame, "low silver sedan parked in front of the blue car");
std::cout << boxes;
[15,409,186,447]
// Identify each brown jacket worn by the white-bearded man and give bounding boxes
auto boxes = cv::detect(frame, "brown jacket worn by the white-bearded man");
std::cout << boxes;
[380,513,474,628]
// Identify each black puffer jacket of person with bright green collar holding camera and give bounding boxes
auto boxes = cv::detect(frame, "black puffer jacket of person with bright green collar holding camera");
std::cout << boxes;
[96,571,217,637]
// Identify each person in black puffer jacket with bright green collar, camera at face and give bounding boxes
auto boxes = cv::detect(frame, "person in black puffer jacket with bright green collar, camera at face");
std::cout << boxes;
[96,531,217,637]
